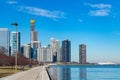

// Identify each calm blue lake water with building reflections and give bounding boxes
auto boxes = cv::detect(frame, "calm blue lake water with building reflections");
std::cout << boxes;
[49,65,120,80]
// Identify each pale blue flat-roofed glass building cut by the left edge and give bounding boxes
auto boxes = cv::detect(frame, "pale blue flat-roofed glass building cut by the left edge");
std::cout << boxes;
[0,28,10,55]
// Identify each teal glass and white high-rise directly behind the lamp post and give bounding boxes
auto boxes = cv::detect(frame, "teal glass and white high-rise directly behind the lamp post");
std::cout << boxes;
[11,32,21,55]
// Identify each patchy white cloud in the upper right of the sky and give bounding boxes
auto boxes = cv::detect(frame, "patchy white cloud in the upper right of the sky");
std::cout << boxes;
[85,3,112,16]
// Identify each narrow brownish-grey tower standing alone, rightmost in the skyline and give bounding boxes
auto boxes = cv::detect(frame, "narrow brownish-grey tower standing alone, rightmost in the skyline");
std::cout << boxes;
[79,44,86,64]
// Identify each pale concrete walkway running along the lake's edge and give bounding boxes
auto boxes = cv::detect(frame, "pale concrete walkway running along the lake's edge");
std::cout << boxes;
[0,66,50,80]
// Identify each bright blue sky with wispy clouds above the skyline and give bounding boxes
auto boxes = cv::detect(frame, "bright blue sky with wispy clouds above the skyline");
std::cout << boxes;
[0,0,120,62]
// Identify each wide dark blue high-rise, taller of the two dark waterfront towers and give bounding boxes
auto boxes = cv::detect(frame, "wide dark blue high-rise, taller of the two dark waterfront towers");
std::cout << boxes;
[62,40,71,62]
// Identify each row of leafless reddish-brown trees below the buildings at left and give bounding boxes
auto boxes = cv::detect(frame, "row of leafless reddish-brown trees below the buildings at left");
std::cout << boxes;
[0,46,38,66]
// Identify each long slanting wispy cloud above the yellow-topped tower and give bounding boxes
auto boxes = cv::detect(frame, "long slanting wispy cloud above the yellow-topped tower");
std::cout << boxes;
[19,6,65,19]
